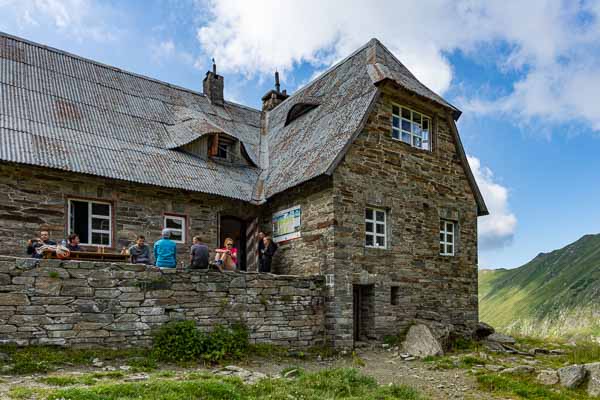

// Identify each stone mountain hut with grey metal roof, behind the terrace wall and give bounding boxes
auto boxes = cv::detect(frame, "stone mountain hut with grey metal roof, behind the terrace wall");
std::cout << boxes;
[0,34,487,346]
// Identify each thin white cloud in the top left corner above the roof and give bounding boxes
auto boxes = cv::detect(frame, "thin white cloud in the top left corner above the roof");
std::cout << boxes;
[0,0,119,42]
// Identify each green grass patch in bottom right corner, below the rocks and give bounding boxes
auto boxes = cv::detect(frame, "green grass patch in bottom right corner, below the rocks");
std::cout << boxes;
[477,374,592,400]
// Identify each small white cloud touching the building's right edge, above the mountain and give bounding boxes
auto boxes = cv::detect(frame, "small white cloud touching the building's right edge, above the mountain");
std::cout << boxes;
[467,156,517,250]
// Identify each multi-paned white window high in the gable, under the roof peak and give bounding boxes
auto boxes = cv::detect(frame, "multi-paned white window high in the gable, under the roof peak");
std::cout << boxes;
[392,105,431,150]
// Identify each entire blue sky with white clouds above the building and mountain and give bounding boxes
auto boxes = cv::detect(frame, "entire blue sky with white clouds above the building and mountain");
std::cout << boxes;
[0,0,600,268]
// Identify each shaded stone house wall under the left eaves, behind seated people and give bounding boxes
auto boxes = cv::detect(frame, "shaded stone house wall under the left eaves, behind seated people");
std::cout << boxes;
[0,163,258,262]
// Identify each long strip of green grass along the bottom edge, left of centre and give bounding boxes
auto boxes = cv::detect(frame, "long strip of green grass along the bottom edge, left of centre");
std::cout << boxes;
[28,368,424,400]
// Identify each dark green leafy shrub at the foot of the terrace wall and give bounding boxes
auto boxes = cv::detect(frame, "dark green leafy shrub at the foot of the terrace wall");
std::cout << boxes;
[153,321,249,363]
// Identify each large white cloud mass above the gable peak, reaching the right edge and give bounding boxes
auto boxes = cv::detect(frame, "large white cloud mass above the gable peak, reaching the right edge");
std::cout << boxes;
[197,0,600,130]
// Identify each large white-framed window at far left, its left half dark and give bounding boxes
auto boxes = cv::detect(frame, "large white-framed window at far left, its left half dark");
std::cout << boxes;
[69,200,112,247]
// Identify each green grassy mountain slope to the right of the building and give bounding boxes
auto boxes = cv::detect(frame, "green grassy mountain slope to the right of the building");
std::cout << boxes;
[479,234,600,336]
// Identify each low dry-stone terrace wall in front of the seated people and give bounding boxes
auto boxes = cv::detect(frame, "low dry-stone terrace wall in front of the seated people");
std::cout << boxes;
[0,256,324,348]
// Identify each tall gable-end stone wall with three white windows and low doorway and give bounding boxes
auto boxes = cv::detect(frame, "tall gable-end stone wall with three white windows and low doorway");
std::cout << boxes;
[327,87,478,346]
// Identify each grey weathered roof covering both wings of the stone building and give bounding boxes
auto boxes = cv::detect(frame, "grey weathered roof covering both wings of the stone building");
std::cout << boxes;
[0,32,487,213]
